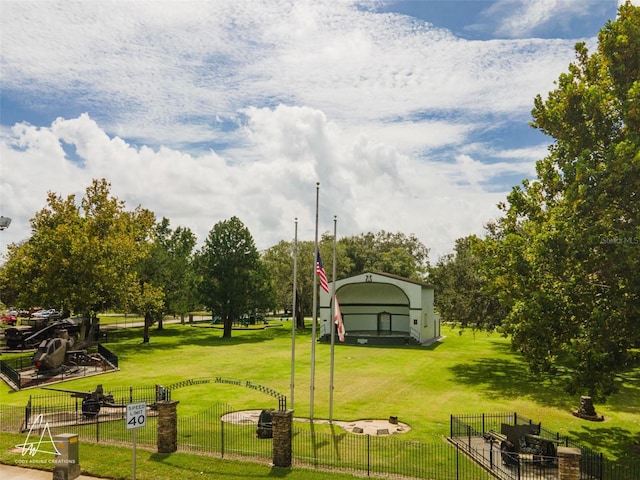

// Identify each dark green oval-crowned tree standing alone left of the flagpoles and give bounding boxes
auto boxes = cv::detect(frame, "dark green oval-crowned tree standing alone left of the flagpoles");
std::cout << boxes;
[196,217,273,338]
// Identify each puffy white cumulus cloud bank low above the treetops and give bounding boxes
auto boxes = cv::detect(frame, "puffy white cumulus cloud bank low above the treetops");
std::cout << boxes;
[0,106,516,255]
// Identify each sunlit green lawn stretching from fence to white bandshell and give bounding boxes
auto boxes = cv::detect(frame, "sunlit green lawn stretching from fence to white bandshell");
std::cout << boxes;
[0,318,640,460]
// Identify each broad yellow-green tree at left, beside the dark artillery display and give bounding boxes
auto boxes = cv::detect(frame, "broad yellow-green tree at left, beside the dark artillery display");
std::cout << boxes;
[4,179,153,334]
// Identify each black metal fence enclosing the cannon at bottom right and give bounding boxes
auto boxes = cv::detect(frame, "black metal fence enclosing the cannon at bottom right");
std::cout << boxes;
[449,412,640,480]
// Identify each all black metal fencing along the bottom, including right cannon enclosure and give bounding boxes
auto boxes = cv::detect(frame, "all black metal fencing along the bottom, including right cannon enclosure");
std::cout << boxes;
[0,396,640,480]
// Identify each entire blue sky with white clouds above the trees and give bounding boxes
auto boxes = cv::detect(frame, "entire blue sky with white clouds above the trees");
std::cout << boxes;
[0,0,638,261]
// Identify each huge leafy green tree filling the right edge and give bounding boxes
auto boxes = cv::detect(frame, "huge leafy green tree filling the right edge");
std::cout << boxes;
[485,3,640,397]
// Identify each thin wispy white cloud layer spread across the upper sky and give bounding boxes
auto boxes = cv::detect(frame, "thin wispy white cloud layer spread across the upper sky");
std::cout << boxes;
[2,0,573,146]
